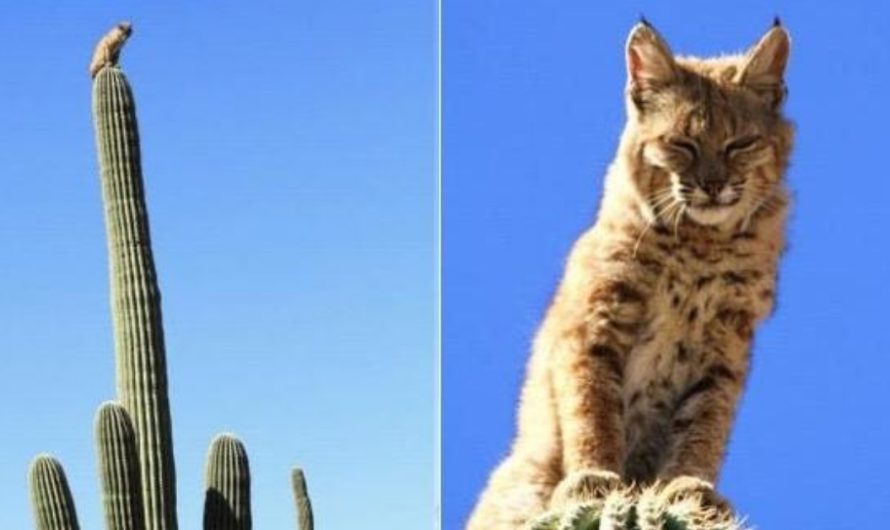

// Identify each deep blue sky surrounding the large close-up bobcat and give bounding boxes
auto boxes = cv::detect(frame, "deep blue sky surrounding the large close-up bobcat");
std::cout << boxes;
[443,0,890,530]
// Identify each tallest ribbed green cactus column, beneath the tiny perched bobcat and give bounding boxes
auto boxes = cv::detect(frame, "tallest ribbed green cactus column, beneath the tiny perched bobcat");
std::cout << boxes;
[93,66,176,530]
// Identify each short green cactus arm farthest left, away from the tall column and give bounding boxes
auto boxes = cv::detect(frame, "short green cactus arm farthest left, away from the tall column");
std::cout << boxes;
[28,455,79,530]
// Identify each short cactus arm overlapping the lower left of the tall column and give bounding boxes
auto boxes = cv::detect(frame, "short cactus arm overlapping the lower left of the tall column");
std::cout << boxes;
[96,402,145,530]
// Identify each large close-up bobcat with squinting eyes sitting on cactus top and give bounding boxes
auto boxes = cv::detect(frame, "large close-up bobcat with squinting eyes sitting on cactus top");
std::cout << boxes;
[468,20,793,530]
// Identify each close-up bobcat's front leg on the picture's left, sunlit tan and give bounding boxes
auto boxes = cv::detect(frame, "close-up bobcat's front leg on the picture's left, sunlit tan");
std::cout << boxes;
[551,279,646,506]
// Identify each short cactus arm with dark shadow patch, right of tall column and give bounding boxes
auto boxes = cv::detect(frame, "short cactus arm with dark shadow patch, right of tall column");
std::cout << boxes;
[204,434,251,530]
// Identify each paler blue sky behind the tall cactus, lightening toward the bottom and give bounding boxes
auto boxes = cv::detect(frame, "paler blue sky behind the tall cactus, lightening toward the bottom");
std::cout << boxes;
[0,0,437,530]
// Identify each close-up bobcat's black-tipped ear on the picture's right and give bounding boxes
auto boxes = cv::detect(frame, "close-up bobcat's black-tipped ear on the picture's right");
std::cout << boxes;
[736,23,791,108]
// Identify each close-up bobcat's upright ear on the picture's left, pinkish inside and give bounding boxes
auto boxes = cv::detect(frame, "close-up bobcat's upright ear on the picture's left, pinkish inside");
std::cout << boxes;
[626,20,677,98]
